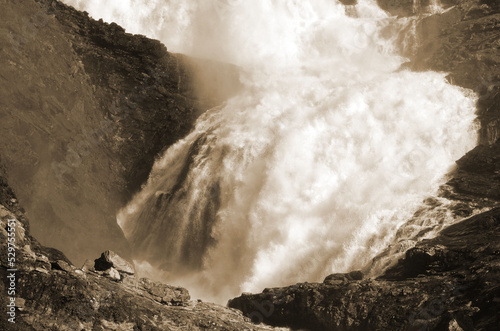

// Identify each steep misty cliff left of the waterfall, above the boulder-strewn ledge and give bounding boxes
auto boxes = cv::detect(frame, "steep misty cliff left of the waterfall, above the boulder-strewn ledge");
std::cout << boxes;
[0,0,239,264]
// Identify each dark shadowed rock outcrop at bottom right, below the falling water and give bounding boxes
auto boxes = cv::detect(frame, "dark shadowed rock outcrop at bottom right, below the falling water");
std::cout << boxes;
[228,208,500,330]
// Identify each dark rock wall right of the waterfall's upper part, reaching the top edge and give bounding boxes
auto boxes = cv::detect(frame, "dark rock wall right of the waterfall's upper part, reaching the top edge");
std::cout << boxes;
[409,0,500,226]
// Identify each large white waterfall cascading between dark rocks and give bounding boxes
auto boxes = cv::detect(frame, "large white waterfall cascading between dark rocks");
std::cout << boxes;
[67,0,476,302]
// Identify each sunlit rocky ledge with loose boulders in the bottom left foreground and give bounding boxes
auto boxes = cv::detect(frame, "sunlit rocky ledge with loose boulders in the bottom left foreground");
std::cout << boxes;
[0,167,282,331]
